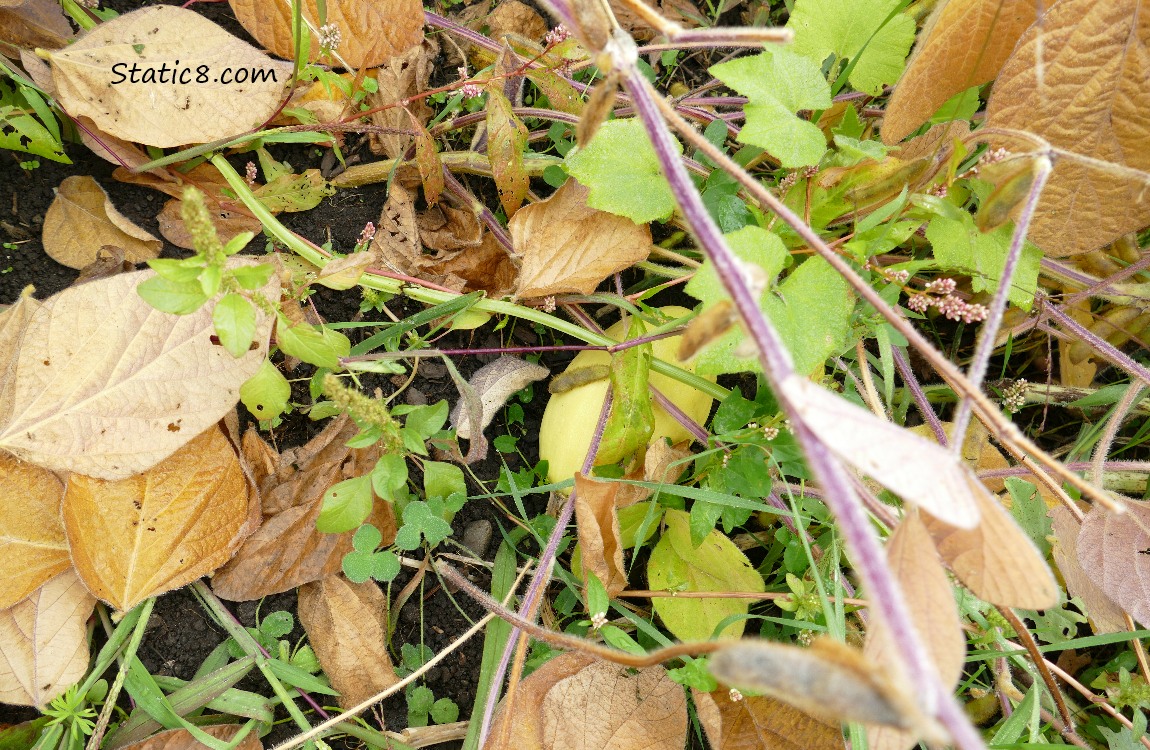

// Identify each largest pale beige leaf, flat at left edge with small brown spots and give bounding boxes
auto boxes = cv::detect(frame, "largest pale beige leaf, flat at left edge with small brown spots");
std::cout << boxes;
[0,259,279,479]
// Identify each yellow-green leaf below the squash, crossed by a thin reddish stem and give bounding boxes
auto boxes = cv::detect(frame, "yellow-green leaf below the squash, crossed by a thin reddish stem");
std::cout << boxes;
[647,510,765,641]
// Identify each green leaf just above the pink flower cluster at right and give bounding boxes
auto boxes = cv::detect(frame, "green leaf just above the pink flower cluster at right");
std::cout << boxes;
[927,213,1042,311]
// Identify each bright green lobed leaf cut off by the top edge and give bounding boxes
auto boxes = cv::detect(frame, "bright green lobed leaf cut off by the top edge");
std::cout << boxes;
[787,0,915,95]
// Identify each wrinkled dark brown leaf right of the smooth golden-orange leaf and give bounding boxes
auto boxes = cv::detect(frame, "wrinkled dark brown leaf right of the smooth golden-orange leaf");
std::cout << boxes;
[212,415,396,602]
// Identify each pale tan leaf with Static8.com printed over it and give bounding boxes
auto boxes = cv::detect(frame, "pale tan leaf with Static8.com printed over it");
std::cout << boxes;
[48,2,291,148]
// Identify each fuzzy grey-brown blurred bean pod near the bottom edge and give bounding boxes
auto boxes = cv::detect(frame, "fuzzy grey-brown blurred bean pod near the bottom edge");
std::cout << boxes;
[711,637,918,729]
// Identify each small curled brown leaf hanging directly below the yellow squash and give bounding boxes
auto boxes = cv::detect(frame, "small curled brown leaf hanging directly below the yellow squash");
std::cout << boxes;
[575,474,627,598]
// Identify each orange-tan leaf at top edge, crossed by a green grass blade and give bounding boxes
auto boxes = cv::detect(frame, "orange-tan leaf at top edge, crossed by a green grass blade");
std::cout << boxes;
[230,0,423,68]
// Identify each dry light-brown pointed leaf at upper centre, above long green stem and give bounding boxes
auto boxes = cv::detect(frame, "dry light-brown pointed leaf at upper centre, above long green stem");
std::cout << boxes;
[508,179,651,298]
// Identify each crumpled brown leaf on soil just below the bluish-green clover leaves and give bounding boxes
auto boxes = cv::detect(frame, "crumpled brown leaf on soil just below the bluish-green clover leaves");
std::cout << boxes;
[299,575,399,711]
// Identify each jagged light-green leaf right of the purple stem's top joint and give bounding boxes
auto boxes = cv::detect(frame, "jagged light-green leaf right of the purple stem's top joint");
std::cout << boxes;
[711,48,830,168]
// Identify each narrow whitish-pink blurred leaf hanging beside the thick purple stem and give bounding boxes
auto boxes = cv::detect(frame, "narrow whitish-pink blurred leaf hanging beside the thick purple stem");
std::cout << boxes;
[782,377,988,529]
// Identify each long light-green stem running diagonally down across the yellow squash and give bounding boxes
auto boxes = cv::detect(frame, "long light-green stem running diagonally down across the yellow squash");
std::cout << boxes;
[212,154,730,400]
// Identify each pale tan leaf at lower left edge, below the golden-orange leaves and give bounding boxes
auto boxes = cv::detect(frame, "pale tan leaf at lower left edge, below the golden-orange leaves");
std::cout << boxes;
[0,569,95,707]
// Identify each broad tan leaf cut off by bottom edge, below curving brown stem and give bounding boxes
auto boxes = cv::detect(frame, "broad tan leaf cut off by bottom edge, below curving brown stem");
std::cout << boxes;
[485,653,687,750]
